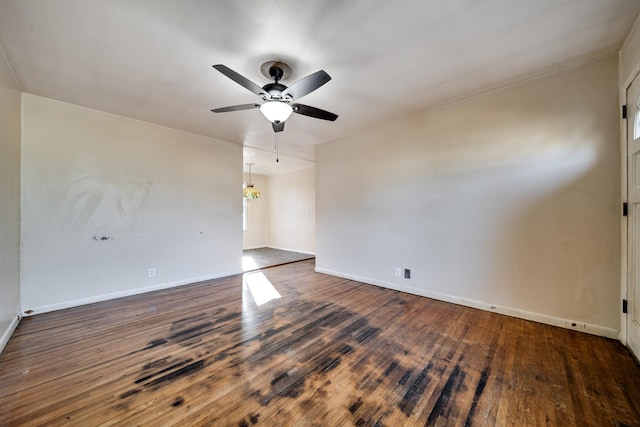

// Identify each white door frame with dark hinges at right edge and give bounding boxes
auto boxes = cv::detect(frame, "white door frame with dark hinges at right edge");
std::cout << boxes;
[618,59,640,346]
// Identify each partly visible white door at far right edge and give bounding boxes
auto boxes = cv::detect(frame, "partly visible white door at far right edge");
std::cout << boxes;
[627,74,640,359]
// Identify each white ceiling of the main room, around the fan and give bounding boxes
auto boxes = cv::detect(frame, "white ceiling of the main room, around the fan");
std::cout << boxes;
[0,0,640,174]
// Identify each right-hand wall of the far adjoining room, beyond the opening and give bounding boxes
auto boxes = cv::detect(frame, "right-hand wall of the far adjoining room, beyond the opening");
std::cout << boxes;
[267,167,316,254]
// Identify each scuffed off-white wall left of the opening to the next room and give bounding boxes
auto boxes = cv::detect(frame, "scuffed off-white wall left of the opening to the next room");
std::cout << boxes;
[22,94,242,313]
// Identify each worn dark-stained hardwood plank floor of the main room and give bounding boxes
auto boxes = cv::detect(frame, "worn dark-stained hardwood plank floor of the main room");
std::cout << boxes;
[0,260,640,426]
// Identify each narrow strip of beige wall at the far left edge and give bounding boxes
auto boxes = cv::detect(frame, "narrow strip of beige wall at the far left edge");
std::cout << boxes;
[0,45,21,351]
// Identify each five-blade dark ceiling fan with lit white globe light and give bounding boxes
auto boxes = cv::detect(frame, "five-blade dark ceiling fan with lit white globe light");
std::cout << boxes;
[211,61,338,132]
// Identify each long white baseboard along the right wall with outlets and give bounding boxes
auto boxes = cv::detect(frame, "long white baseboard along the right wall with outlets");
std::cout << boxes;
[316,267,620,339]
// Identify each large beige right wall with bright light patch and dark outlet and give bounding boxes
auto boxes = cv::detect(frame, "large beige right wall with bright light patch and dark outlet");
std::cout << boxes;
[316,56,621,337]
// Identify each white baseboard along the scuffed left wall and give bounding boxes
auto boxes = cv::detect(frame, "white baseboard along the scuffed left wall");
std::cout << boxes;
[22,270,242,316]
